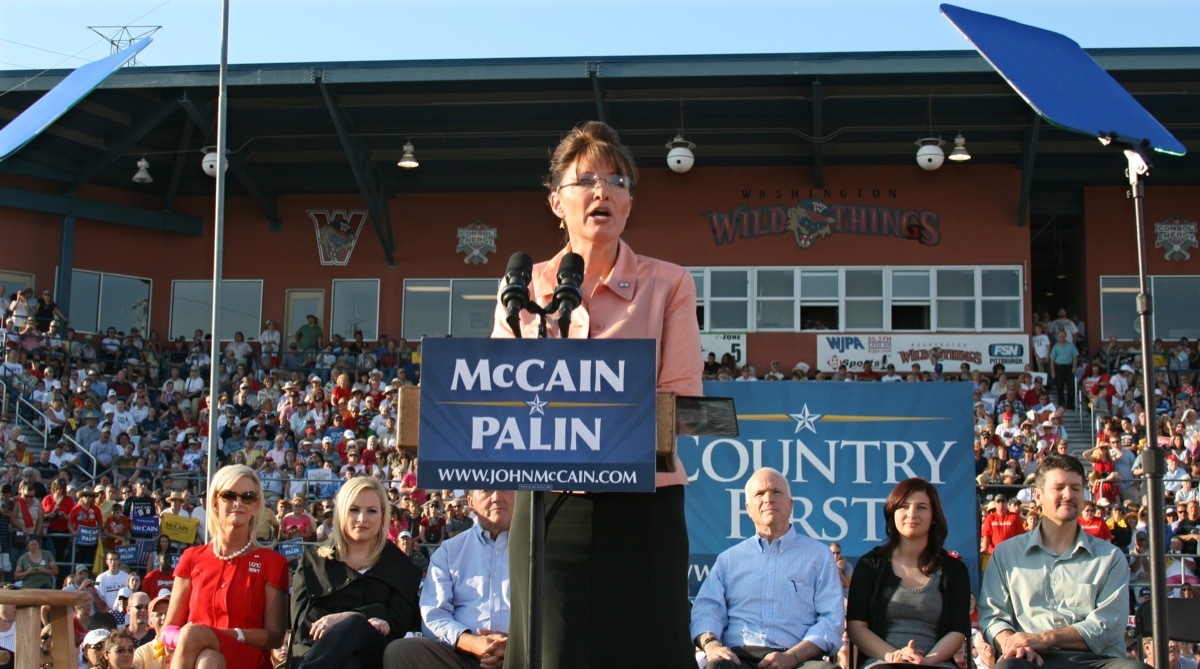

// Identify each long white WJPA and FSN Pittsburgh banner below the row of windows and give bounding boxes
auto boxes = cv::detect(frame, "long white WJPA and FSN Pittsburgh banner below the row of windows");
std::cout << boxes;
[817,333,1030,375]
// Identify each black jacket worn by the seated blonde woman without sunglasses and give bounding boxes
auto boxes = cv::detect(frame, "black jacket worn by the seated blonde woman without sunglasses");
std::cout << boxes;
[292,542,421,657]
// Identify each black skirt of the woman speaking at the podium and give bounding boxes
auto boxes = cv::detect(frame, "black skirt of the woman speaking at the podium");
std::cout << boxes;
[504,486,696,669]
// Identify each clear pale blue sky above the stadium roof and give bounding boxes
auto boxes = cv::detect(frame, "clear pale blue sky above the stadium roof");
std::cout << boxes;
[0,0,1200,70]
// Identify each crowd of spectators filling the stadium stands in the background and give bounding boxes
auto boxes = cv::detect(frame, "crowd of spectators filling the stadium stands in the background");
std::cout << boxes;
[0,290,1200,657]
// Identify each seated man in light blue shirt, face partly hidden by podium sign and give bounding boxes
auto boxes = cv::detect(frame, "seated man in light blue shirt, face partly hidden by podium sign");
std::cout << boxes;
[383,490,513,669]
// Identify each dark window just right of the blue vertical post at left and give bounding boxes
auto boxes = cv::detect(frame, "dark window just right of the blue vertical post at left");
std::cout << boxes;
[67,270,151,333]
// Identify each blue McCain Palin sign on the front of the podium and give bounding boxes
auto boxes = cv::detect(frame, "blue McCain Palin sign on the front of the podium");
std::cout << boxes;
[418,338,658,492]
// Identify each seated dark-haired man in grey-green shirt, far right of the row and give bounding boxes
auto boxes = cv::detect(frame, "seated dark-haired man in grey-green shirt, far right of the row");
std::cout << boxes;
[979,454,1146,669]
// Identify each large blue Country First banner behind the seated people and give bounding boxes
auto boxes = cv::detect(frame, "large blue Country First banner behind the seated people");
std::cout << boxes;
[679,381,979,596]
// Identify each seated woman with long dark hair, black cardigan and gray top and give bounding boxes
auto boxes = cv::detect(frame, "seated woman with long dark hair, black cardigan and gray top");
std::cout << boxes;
[846,478,971,669]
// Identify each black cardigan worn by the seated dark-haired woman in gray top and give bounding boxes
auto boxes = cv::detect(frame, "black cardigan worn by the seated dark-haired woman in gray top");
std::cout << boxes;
[846,546,971,665]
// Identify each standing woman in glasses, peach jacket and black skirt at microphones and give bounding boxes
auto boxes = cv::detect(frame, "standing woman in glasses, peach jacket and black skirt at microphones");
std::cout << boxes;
[492,121,703,669]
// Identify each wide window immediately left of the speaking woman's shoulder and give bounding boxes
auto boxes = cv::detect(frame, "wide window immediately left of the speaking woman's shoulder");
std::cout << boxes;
[401,279,499,340]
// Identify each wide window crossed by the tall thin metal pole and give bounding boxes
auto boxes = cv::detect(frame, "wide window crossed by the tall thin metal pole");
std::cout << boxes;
[170,281,263,342]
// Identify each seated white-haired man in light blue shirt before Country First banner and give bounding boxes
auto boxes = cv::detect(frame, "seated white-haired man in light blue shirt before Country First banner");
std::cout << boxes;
[691,468,846,669]
